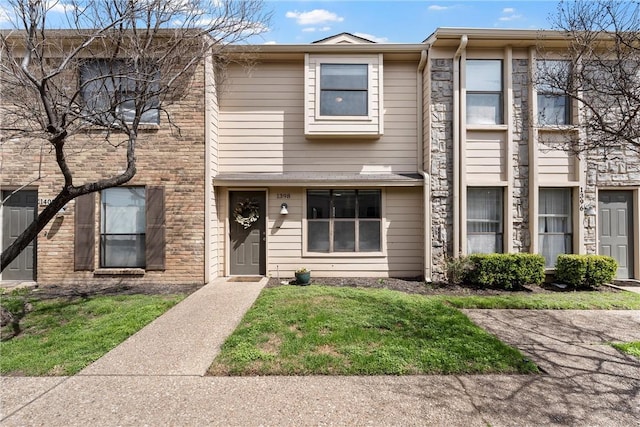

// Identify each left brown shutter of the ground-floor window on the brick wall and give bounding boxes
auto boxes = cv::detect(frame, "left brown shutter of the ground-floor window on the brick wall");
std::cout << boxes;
[74,193,96,271]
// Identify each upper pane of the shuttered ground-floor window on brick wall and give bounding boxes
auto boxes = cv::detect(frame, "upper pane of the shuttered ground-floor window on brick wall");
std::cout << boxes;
[101,187,146,234]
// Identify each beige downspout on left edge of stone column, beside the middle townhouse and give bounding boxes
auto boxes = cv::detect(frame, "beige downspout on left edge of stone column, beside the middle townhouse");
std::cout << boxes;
[417,45,432,283]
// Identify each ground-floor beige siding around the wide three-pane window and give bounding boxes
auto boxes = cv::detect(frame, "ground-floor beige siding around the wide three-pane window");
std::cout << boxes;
[267,188,423,279]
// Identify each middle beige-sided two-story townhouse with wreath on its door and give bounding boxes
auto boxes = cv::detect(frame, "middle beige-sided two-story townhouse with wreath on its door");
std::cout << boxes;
[211,34,430,278]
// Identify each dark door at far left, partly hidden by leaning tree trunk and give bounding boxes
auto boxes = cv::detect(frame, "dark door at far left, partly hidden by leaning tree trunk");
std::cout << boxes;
[1,191,38,281]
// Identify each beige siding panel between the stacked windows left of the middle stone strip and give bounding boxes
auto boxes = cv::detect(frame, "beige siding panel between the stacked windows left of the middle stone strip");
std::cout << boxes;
[464,131,506,183]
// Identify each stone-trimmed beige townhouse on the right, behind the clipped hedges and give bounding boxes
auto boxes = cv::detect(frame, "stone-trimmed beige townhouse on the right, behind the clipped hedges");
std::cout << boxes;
[424,29,640,279]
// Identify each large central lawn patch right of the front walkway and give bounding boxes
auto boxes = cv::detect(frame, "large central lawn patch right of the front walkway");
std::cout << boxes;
[209,286,537,375]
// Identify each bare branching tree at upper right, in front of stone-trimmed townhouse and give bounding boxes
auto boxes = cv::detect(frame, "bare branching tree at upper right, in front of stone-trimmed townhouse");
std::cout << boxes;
[536,0,640,155]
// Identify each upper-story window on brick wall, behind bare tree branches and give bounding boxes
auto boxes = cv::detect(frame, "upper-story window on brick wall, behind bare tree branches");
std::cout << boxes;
[80,59,160,124]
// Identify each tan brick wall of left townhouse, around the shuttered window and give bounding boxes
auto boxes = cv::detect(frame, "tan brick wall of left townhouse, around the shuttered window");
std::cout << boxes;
[0,62,205,285]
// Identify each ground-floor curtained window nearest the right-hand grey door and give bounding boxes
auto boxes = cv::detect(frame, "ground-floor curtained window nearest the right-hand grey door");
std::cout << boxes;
[538,188,573,267]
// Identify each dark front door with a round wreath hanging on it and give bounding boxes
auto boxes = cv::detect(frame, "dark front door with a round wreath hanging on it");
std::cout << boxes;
[229,191,266,275]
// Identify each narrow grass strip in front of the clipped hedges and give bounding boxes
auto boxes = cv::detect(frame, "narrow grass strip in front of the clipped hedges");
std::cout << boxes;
[431,291,640,310]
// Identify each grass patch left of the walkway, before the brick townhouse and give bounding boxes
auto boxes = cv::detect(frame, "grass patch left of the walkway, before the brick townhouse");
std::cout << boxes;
[0,295,185,376]
